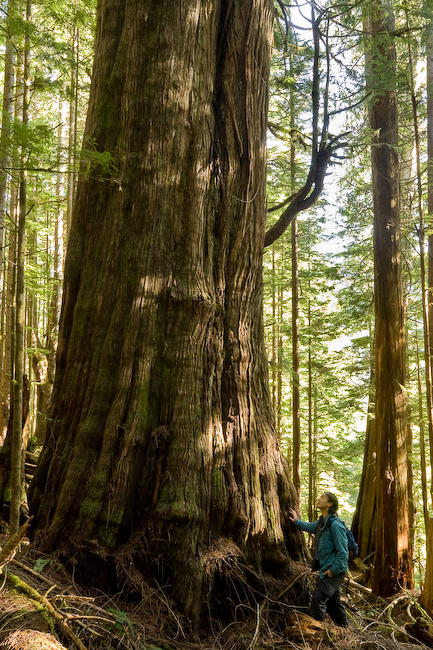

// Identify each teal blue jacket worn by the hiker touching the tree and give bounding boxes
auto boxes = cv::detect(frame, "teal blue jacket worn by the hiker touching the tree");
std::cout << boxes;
[295,515,349,578]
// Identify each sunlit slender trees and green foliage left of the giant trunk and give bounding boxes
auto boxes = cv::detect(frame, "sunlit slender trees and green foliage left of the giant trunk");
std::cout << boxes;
[0,0,94,519]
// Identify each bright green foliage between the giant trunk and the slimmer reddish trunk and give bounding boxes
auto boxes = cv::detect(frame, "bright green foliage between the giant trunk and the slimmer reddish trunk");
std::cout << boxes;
[264,0,373,516]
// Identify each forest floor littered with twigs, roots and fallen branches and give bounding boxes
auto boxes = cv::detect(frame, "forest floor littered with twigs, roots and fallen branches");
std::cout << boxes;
[0,542,433,650]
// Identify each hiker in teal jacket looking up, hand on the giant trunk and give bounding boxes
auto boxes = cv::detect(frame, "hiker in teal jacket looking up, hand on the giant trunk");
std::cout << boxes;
[289,492,349,627]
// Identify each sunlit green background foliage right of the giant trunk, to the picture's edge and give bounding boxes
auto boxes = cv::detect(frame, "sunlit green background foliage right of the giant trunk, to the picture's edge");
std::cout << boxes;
[265,0,432,560]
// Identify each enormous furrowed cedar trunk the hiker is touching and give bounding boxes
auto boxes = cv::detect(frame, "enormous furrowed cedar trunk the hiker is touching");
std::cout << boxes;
[32,0,300,619]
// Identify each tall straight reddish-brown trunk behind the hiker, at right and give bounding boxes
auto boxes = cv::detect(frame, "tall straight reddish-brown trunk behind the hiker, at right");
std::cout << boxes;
[366,0,412,596]
